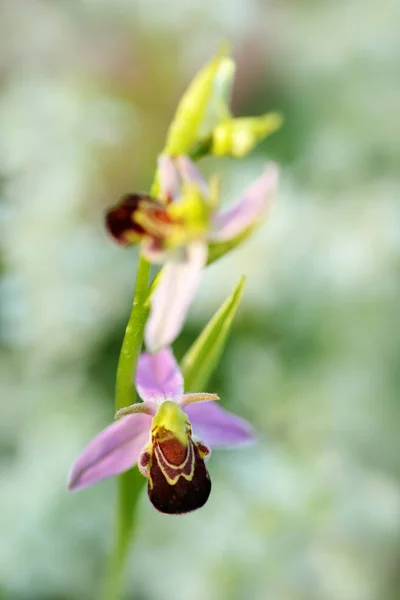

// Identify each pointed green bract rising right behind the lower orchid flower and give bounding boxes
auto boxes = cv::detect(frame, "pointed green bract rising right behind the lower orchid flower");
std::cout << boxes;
[181,276,245,392]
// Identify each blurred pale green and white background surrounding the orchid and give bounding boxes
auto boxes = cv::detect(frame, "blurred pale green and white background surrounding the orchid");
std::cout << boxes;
[0,0,400,600]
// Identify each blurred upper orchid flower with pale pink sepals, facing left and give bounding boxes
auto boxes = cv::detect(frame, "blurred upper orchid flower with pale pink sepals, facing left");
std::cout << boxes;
[106,155,279,352]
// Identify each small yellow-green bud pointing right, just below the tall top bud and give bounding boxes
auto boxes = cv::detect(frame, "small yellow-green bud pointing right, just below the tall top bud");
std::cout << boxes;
[211,112,283,158]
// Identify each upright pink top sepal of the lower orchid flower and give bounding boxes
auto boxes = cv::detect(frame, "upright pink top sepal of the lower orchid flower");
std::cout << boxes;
[136,348,183,400]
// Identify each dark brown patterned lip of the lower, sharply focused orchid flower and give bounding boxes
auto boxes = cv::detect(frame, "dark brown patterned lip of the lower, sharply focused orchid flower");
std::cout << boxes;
[147,438,211,514]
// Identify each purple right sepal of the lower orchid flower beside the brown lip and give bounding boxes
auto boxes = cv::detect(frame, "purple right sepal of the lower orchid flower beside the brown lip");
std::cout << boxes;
[184,402,256,448]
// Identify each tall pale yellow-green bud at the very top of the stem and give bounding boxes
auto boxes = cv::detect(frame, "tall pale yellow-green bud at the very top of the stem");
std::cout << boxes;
[163,51,231,156]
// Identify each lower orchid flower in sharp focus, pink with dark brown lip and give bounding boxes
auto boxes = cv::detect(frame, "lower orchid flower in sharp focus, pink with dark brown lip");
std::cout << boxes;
[69,348,254,514]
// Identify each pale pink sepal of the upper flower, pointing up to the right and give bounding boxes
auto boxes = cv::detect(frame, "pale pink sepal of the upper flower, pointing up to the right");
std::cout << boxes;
[210,162,279,242]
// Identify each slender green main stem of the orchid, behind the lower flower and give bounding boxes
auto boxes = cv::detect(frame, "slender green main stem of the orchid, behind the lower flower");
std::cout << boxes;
[103,256,150,600]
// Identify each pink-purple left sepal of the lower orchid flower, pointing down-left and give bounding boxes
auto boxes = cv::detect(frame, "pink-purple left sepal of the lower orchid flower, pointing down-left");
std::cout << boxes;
[68,414,152,491]
